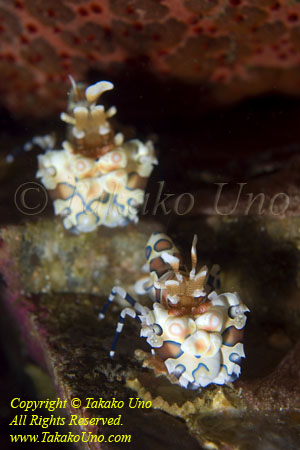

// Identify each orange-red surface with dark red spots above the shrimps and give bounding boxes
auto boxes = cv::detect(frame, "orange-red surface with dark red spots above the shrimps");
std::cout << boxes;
[0,0,300,114]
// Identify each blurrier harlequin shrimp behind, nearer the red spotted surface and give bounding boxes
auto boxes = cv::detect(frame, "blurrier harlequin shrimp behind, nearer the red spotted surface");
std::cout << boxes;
[7,77,157,232]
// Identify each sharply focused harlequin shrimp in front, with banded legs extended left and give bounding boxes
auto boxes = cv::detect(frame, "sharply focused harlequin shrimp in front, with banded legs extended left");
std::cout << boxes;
[99,233,249,389]
